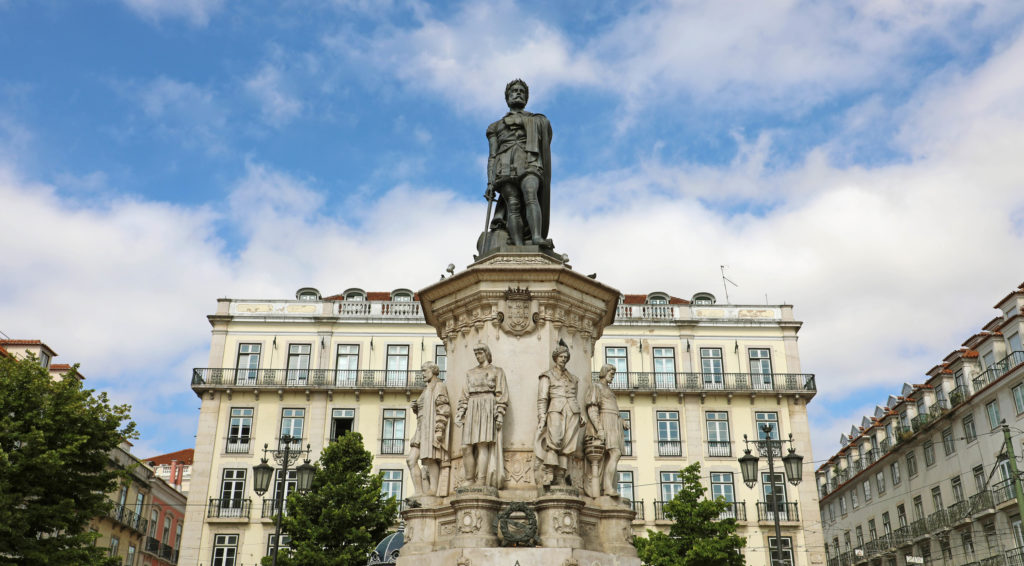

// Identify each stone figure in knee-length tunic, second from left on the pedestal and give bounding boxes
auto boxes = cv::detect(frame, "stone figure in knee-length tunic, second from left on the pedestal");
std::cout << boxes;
[455,344,508,489]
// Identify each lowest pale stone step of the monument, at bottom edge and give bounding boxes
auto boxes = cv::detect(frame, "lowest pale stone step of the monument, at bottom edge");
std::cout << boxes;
[396,548,640,566]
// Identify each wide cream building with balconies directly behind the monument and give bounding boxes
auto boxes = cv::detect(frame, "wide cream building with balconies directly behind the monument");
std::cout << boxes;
[182,288,824,566]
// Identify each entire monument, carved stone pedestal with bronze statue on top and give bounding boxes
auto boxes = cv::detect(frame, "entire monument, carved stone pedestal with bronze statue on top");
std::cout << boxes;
[398,79,640,566]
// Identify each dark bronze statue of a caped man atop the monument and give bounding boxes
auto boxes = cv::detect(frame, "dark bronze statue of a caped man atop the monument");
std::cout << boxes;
[485,79,554,249]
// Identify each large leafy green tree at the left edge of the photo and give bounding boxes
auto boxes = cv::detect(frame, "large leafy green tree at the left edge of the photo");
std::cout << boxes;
[0,356,135,566]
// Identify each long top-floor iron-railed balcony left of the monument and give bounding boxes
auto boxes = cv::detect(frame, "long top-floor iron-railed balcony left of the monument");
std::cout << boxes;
[191,367,423,392]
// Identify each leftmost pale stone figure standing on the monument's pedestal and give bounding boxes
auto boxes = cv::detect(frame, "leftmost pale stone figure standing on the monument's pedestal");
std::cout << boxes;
[407,361,452,496]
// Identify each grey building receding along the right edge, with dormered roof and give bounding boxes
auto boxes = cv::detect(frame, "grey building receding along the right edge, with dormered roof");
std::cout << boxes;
[816,285,1024,566]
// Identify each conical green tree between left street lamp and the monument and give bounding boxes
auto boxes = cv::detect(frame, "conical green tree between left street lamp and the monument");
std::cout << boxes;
[263,432,398,566]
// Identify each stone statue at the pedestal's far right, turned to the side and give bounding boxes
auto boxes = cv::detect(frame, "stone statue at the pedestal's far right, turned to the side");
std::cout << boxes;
[584,363,629,497]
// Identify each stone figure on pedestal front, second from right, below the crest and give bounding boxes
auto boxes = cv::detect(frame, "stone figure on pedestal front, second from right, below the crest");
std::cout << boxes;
[534,340,584,485]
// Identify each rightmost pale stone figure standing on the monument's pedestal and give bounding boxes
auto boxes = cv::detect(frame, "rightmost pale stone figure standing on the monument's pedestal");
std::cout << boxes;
[587,363,629,491]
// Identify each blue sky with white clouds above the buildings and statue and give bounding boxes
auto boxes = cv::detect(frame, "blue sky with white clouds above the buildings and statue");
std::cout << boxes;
[0,0,1024,461]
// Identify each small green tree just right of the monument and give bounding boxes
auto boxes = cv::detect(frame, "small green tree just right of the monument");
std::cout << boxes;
[635,463,746,566]
